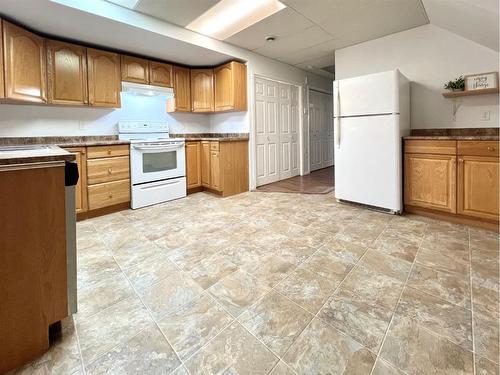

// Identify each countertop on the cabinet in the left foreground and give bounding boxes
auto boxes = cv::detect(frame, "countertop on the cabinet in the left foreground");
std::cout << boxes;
[0,145,75,169]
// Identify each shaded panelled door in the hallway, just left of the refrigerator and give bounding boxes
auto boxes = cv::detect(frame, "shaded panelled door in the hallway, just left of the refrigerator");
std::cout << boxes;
[309,89,334,172]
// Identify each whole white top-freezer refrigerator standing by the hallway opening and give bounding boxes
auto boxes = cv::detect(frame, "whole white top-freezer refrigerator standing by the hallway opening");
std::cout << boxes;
[333,70,410,213]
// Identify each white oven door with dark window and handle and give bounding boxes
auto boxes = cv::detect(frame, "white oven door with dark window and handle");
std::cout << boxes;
[130,142,186,185]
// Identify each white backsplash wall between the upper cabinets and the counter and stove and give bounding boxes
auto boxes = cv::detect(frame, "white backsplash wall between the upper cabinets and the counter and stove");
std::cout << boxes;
[0,94,210,137]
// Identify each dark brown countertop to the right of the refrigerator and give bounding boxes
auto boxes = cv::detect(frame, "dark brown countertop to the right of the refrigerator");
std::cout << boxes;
[403,128,499,141]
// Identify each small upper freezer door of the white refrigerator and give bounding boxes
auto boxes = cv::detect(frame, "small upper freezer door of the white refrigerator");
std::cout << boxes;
[334,70,401,117]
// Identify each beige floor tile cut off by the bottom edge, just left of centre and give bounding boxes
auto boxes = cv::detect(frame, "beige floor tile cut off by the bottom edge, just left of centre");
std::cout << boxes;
[186,323,278,375]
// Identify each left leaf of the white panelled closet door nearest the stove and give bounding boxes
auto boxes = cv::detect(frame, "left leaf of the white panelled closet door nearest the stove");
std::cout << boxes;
[255,78,280,186]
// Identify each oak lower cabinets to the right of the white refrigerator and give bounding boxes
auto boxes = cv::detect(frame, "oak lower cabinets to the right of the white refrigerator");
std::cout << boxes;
[404,140,500,227]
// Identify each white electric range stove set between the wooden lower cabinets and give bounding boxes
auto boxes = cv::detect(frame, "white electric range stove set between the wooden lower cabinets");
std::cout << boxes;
[118,121,186,209]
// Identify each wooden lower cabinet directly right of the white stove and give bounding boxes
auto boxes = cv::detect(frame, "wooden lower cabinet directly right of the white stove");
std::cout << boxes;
[186,140,248,197]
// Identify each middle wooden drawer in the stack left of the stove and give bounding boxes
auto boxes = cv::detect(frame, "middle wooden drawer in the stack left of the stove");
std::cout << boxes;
[87,156,130,185]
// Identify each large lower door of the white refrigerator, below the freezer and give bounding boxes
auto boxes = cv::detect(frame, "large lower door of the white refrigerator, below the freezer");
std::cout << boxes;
[335,115,402,211]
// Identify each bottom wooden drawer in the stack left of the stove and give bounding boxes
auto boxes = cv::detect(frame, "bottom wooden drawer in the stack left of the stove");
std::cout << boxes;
[88,179,130,210]
